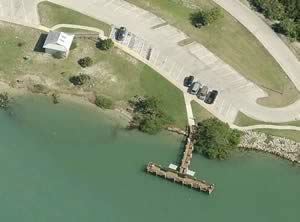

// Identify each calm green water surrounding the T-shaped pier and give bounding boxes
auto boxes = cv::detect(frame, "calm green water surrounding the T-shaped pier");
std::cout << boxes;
[0,96,300,222]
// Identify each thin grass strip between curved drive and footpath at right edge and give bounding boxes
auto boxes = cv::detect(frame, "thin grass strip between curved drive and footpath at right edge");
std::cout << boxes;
[234,112,300,126]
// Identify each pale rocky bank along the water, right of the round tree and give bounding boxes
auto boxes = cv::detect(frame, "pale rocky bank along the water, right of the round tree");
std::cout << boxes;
[239,131,300,163]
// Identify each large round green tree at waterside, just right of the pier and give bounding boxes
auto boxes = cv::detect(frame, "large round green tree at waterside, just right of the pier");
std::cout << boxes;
[194,118,240,159]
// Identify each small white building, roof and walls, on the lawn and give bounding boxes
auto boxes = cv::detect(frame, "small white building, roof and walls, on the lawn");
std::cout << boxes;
[43,31,74,57]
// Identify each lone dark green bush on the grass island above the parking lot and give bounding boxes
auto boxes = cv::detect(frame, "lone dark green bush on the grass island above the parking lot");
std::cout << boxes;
[191,7,223,28]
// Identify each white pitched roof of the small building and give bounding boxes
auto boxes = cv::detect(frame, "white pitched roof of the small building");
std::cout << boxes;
[43,31,74,52]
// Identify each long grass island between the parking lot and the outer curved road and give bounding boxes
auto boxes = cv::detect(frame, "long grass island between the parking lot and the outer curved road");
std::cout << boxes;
[128,0,299,107]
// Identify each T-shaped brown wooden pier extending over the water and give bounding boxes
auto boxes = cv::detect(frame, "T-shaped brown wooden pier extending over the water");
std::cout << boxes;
[146,126,214,194]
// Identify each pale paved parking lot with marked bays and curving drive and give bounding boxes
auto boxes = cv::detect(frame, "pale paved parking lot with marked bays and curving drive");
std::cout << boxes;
[0,0,300,122]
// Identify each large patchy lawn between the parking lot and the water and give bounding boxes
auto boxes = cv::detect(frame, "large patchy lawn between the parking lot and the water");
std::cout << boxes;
[0,23,186,128]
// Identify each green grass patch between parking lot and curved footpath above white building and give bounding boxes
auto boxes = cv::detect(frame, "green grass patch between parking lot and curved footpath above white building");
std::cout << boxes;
[38,2,111,35]
